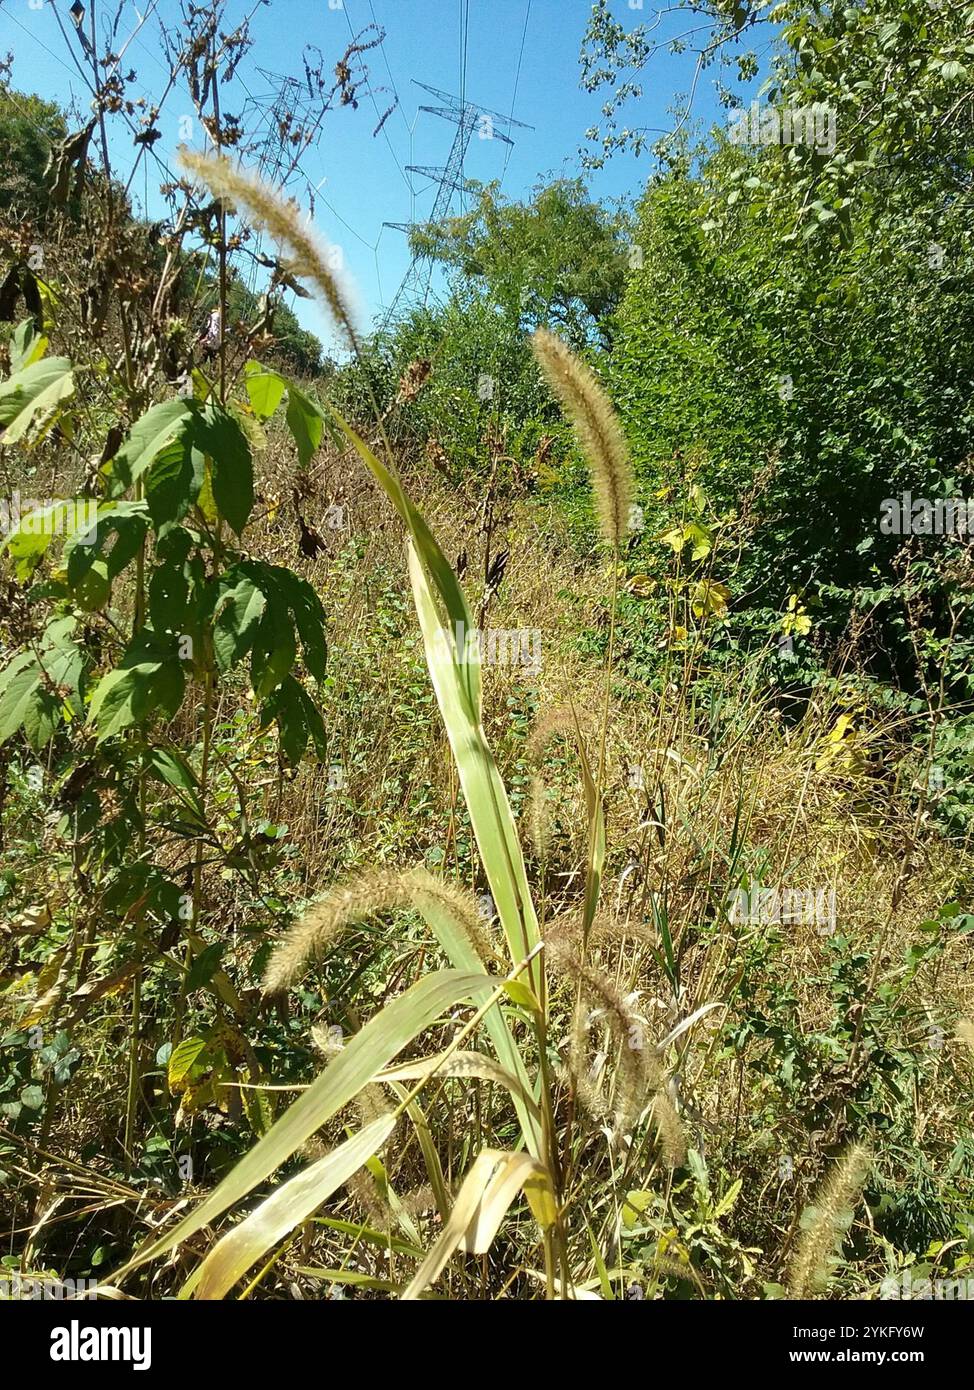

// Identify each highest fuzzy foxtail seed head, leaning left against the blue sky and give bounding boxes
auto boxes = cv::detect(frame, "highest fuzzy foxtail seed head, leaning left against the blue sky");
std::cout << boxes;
[179,149,360,352]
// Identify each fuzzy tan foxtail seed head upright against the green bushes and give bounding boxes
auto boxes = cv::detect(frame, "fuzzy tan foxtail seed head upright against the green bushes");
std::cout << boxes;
[531,328,634,545]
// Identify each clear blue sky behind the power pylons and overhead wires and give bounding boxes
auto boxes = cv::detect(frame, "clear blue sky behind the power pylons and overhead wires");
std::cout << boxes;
[0,0,766,346]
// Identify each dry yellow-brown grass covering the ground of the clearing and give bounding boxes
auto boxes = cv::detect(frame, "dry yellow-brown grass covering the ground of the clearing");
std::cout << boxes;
[3,403,974,1297]
